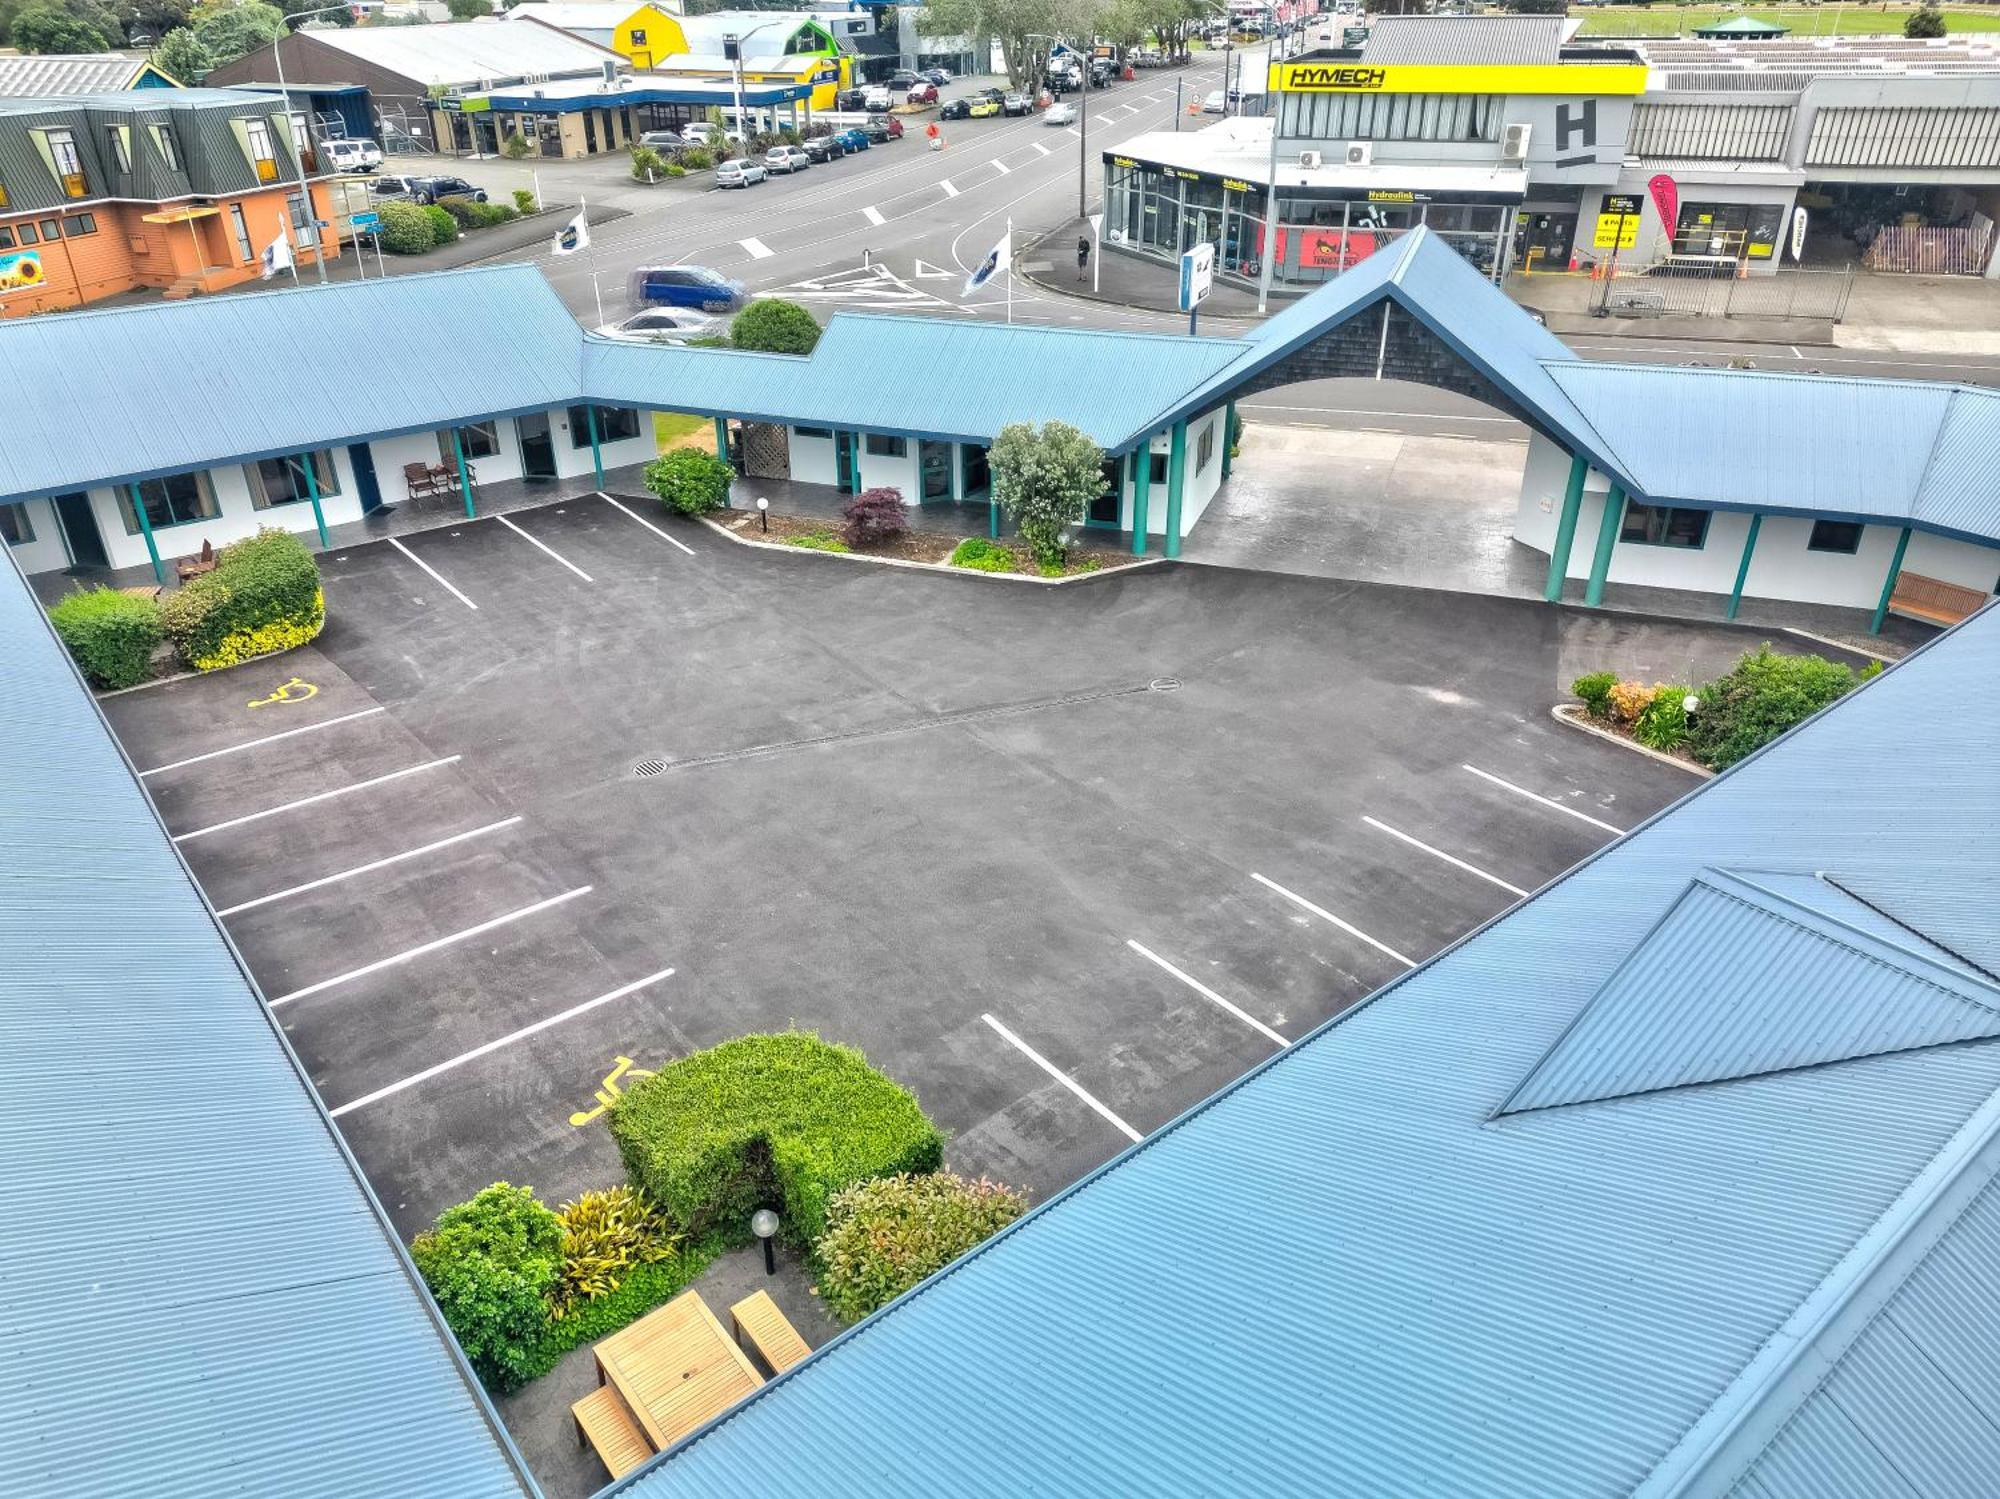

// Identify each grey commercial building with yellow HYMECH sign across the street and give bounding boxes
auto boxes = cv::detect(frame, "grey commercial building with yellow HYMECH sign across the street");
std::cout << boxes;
[1104,16,2000,294]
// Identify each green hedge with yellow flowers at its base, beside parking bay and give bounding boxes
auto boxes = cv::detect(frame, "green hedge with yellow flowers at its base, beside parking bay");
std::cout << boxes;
[160,532,326,672]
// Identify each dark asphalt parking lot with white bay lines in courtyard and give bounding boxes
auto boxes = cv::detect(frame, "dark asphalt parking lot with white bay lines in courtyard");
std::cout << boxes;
[106,498,1704,1233]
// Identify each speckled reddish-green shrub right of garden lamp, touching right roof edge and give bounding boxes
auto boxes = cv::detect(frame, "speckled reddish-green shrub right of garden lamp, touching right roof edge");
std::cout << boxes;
[814,1171,1028,1321]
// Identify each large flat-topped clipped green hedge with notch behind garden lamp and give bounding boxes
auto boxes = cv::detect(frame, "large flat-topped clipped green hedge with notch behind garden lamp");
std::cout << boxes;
[610,1031,944,1247]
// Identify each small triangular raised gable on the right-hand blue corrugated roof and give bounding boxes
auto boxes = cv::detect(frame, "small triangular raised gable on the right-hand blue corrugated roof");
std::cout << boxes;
[1500,869,2000,1113]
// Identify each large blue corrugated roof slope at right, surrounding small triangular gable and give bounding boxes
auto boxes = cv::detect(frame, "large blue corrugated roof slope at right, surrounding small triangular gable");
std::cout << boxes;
[622,610,2000,1499]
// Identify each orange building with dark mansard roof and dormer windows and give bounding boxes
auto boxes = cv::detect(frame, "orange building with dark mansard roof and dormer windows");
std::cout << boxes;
[0,88,340,318]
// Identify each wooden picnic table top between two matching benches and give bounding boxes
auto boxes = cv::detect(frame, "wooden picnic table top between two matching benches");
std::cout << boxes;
[596,1291,764,1451]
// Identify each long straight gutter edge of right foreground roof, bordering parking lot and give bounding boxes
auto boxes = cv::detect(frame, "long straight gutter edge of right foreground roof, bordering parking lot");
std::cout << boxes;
[620,614,2000,1499]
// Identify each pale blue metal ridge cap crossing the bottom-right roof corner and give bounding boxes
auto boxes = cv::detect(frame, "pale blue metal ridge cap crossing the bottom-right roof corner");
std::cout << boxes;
[1632,1089,2000,1499]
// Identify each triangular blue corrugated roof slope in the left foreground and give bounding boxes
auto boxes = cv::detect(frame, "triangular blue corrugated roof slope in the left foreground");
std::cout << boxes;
[0,551,534,1499]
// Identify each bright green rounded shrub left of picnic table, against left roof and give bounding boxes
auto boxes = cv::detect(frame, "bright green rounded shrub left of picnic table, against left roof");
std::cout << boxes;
[410,1181,562,1395]
